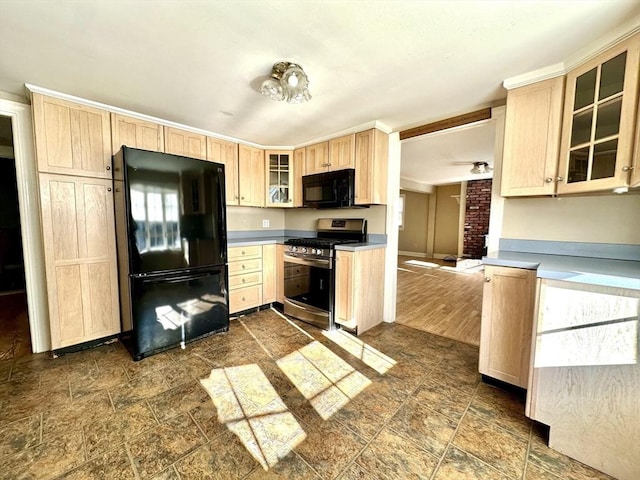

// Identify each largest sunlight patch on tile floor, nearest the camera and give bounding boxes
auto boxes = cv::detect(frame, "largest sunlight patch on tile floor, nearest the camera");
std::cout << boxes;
[200,364,307,470]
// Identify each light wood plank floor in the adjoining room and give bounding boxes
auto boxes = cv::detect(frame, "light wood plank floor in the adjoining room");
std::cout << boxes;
[396,255,484,345]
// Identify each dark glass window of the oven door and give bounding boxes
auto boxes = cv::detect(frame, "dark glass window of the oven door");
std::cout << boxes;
[284,258,332,312]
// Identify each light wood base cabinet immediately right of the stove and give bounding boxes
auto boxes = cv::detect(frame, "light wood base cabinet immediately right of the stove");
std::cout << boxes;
[335,248,385,335]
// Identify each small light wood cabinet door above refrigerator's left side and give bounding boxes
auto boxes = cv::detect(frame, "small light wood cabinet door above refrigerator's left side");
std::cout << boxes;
[111,113,164,155]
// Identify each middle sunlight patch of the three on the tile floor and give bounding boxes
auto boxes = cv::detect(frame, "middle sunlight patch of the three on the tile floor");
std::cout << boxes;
[276,340,371,420]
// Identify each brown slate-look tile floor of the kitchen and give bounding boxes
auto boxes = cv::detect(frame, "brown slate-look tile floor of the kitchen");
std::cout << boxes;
[0,310,609,480]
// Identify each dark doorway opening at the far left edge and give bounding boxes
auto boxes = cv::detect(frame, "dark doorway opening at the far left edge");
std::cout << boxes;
[0,116,32,361]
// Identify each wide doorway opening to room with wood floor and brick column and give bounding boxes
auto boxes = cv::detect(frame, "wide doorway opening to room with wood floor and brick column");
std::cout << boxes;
[396,115,502,346]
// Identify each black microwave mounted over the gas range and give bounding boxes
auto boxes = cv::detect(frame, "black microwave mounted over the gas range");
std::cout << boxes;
[302,168,366,208]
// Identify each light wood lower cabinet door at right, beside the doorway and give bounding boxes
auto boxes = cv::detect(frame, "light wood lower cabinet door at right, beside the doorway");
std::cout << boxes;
[479,265,536,388]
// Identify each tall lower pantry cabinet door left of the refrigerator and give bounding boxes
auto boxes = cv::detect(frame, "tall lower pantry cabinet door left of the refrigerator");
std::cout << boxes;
[39,173,120,350]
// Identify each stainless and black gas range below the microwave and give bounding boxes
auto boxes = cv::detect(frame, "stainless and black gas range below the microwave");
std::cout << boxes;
[284,218,367,330]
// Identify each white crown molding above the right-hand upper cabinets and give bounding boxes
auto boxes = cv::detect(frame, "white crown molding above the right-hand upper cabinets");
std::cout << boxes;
[502,15,640,90]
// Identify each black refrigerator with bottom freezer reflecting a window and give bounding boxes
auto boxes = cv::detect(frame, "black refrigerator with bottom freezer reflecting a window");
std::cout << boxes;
[114,146,229,360]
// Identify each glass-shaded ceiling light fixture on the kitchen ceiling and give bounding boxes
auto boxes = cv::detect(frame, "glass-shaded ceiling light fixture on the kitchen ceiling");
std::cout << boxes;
[260,62,311,103]
